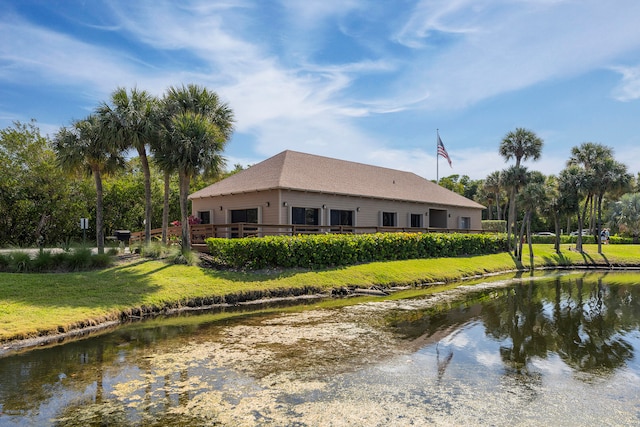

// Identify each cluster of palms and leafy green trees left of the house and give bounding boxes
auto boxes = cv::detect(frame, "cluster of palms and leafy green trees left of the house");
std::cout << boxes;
[0,85,234,253]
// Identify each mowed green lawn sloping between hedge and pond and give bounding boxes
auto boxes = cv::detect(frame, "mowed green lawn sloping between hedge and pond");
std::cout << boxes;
[0,244,640,342]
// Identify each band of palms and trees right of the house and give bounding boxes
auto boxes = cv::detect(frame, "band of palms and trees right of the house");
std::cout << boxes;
[440,128,640,260]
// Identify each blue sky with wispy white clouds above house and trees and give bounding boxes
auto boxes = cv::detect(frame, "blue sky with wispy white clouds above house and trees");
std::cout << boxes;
[0,0,640,179]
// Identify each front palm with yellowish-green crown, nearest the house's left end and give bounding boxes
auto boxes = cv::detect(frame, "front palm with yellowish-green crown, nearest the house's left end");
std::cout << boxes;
[166,111,226,252]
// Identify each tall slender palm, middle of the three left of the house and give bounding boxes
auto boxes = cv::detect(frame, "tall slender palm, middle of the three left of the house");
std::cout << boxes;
[97,87,159,243]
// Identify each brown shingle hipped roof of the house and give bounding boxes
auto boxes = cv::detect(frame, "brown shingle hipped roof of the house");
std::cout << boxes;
[189,150,484,209]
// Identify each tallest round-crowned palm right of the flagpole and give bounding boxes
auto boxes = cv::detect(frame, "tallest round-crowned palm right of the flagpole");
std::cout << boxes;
[499,128,543,251]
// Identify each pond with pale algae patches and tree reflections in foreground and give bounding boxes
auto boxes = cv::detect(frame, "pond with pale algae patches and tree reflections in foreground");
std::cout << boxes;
[0,272,640,426]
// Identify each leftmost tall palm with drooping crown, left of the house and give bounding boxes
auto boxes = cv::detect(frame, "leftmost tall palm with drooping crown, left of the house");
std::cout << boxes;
[54,115,124,254]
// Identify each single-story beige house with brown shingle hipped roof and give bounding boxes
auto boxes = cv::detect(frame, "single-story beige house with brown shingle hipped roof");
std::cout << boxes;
[189,150,485,237]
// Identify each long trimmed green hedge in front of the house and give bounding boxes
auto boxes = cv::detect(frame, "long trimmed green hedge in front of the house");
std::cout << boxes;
[206,233,506,269]
